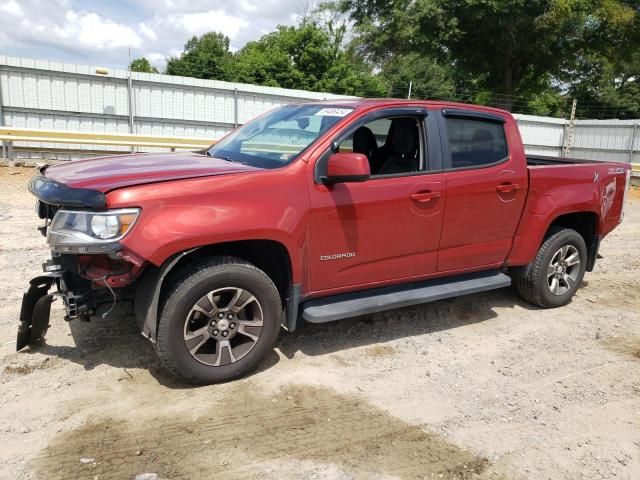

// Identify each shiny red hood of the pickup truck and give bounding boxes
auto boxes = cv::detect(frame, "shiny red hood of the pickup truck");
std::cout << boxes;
[44,152,260,193]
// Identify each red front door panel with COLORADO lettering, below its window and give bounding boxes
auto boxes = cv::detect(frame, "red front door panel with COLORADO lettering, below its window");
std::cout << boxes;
[309,174,446,291]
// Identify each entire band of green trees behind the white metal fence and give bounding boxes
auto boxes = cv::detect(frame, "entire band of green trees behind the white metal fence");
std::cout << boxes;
[156,0,640,118]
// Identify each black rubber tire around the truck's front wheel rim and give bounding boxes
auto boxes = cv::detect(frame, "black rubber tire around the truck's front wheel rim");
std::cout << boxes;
[156,257,282,385]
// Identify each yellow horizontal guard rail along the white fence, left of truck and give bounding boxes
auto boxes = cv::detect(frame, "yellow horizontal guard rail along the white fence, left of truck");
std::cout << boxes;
[0,127,215,149]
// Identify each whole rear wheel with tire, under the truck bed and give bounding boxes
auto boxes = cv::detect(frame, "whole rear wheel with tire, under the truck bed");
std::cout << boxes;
[515,228,587,308]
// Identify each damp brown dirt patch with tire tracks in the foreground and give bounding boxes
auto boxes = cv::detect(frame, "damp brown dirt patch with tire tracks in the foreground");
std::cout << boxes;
[32,384,496,479]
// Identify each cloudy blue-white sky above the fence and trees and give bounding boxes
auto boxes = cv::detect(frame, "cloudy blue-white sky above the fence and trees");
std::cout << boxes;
[0,0,313,68]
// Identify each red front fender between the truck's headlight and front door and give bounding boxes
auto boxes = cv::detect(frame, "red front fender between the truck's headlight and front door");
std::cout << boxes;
[107,162,309,283]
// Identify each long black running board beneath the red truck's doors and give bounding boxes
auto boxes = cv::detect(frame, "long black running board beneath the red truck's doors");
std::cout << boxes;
[302,270,511,323]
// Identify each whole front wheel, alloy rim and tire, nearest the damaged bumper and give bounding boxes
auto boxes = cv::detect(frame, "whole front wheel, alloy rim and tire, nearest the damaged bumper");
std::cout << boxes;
[157,257,282,384]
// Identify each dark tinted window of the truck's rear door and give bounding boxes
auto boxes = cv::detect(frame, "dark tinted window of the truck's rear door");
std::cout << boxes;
[446,118,509,168]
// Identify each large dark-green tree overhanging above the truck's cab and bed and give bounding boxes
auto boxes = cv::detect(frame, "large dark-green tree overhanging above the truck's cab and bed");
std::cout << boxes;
[340,0,637,109]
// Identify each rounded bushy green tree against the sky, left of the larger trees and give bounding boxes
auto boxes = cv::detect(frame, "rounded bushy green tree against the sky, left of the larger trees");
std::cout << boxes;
[165,32,234,80]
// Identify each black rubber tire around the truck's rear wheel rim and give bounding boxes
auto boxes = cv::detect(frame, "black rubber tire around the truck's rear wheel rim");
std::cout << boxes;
[515,228,587,308]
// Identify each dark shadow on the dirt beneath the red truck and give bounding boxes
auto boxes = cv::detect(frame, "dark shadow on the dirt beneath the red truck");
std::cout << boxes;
[26,288,535,388]
